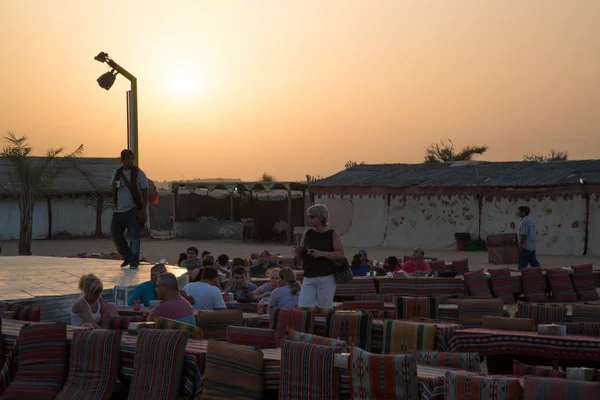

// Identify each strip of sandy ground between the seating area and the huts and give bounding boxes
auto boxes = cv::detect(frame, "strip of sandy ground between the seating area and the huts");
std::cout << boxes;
[0,238,600,269]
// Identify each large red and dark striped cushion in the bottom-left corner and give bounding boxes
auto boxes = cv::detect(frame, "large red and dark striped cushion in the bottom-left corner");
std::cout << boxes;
[2,324,70,400]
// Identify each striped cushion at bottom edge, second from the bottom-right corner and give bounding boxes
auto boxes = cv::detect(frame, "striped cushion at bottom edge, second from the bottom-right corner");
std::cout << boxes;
[444,371,521,400]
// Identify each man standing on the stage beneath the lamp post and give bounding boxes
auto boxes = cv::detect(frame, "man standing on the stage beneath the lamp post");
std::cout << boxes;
[110,150,148,269]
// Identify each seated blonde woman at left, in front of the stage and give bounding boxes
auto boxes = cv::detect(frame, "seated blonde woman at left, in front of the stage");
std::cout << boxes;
[71,274,118,329]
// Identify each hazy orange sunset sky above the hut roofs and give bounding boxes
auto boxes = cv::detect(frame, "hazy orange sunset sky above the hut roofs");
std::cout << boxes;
[0,0,600,180]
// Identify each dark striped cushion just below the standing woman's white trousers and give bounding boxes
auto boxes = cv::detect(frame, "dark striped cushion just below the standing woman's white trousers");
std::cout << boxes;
[325,313,373,350]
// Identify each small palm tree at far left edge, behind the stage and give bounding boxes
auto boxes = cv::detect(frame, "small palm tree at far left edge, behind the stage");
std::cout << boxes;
[0,132,83,255]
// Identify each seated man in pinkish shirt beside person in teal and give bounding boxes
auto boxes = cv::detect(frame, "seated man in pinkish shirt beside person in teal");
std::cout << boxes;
[148,272,196,325]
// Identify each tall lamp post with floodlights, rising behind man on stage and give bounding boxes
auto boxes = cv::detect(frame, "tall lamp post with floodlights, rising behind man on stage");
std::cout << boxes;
[94,52,139,165]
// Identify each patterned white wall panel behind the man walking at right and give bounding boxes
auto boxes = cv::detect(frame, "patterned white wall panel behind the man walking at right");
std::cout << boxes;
[481,195,584,256]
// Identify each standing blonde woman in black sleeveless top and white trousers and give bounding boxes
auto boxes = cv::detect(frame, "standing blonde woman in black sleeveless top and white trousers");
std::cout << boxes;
[295,204,345,308]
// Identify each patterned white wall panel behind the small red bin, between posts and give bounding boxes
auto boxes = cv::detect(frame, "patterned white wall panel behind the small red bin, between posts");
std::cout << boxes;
[386,195,479,249]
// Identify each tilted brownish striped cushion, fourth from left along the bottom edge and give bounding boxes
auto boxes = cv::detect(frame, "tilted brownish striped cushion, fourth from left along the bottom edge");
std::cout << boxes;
[202,340,264,400]
